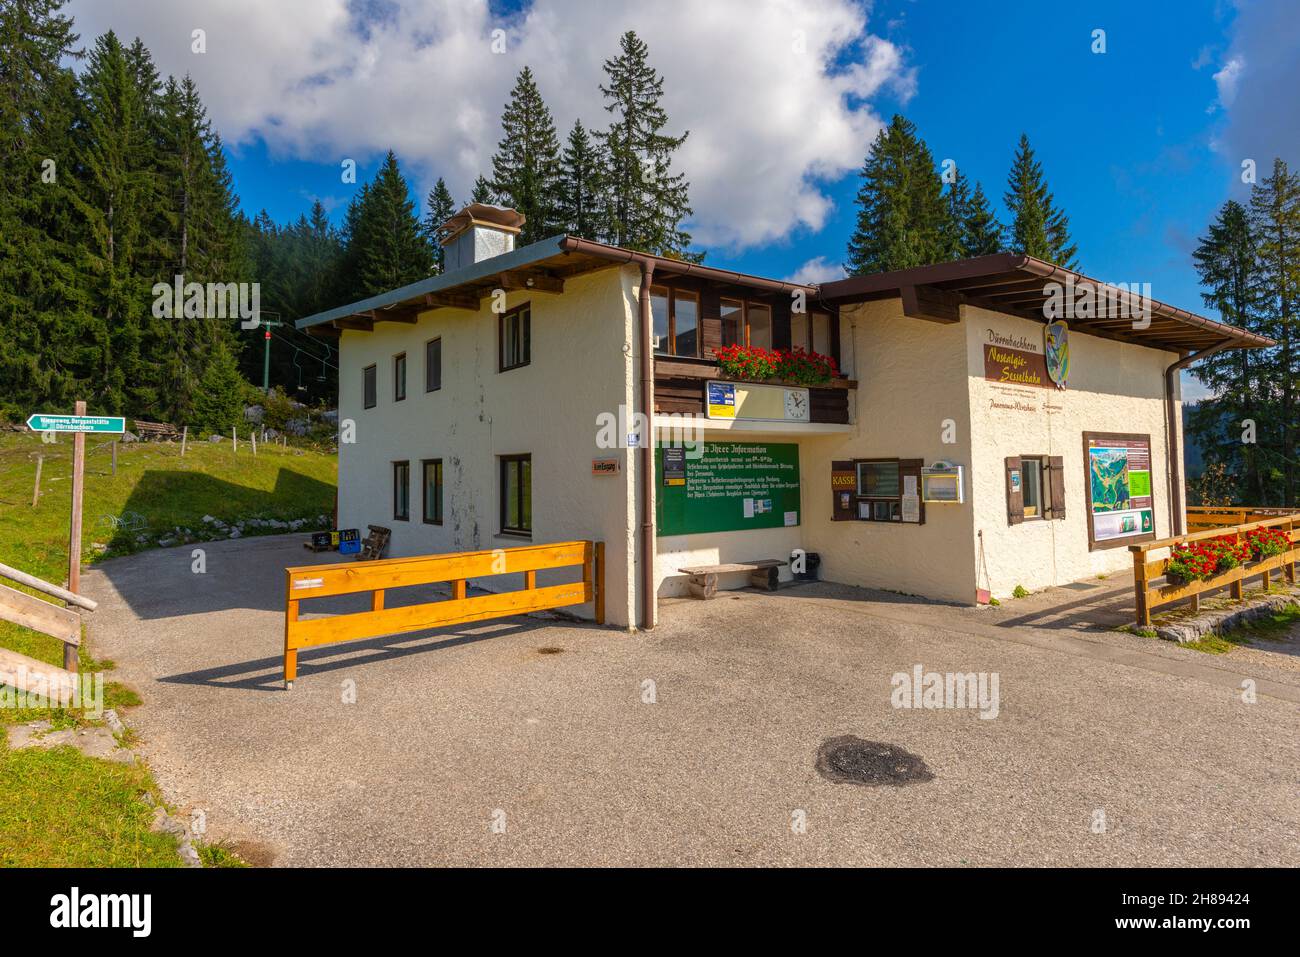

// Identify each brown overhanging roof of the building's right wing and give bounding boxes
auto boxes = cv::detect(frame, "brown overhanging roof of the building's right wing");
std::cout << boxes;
[819,252,1278,354]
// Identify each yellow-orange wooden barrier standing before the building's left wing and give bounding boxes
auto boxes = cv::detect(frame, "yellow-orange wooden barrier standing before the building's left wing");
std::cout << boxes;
[285,542,605,688]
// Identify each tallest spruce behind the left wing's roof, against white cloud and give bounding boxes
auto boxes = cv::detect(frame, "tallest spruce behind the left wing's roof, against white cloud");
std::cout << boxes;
[595,30,703,261]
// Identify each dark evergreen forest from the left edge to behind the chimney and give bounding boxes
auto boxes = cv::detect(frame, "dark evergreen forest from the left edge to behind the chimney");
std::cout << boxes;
[0,0,698,429]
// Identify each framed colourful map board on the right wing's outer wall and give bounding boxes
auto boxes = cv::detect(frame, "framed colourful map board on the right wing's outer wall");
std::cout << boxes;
[1083,432,1156,550]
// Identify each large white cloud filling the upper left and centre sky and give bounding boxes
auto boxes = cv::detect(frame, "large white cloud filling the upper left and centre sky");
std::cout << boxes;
[63,0,915,250]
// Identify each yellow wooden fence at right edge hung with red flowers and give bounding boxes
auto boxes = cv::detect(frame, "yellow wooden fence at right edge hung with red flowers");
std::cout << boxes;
[1128,508,1300,627]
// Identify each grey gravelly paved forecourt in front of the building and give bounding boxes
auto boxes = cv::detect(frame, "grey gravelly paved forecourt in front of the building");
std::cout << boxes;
[83,536,1300,866]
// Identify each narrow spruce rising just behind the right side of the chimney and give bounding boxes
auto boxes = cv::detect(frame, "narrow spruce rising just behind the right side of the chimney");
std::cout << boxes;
[491,66,559,246]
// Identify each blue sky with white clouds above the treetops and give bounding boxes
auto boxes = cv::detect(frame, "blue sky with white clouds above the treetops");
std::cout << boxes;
[70,0,1300,400]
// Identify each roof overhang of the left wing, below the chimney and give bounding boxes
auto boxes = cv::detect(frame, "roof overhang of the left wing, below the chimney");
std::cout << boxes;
[295,235,818,337]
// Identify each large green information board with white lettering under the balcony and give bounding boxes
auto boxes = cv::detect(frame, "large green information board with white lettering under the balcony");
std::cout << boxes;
[655,442,800,536]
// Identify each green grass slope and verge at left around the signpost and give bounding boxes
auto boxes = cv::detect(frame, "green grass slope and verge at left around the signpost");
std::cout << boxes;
[0,432,338,867]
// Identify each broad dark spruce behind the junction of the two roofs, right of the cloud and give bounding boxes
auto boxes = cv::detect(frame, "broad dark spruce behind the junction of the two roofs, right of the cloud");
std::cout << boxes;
[845,116,954,276]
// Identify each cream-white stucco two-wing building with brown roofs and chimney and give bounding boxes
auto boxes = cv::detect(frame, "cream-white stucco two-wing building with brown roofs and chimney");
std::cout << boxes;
[298,204,1270,625]
